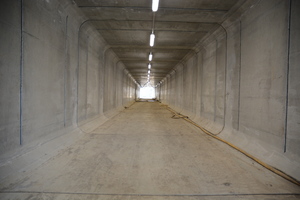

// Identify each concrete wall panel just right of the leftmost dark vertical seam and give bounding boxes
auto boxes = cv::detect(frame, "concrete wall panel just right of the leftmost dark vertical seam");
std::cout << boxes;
[23,1,65,143]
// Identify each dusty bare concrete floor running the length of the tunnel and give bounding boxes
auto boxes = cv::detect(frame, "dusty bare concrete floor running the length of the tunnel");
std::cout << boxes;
[0,102,300,200]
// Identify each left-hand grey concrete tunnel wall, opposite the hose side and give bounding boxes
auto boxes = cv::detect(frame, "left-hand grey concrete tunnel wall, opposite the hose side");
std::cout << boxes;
[0,0,136,164]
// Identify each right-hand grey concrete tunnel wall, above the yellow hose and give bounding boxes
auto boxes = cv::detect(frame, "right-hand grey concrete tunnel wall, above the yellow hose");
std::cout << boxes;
[157,0,300,180]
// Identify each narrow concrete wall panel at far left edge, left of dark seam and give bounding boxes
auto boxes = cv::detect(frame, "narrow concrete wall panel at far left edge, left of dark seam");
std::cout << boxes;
[0,0,21,152]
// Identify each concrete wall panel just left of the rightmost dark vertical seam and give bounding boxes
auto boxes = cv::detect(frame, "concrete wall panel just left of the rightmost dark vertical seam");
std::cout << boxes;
[240,2,288,146]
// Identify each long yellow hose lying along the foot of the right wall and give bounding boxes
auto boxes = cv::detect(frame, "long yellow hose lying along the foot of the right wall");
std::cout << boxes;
[162,105,300,186]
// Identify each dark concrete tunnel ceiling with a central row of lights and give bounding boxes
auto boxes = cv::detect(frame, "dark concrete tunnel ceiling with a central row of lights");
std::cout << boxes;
[75,0,241,85]
